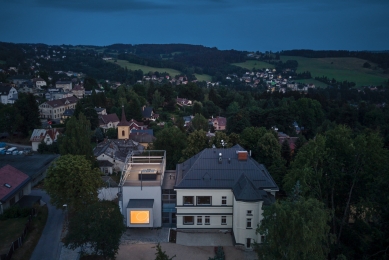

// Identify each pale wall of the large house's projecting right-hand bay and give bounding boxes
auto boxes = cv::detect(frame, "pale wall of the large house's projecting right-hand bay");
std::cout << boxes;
[233,199,263,246]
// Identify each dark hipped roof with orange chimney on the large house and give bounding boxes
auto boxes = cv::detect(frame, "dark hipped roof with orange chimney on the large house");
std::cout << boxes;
[175,145,278,201]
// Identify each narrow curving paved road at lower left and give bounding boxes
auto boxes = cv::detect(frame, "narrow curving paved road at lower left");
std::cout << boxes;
[30,189,64,260]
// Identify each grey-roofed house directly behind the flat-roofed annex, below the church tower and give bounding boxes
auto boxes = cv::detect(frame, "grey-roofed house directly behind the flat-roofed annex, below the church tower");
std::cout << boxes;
[93,139,144,171]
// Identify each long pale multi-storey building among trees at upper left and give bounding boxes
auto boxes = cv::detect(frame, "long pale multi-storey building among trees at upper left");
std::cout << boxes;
[39,96,78,121]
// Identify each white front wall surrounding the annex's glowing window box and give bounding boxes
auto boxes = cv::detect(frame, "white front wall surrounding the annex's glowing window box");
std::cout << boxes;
[122,186,162,227]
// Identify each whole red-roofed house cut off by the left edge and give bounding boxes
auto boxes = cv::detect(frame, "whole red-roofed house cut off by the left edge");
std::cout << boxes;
[0,165,31,214]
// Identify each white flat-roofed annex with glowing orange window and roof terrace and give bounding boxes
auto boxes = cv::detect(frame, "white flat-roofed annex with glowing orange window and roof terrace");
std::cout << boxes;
[119,150,166,228]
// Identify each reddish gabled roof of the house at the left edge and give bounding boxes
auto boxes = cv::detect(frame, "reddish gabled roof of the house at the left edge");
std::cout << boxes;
[0,165,30,203]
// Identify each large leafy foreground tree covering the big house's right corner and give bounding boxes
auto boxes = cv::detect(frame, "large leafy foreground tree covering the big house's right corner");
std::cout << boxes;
[255,191,330,260]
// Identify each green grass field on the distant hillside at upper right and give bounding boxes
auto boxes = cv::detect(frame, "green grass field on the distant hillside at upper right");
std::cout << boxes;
[281,56,389,87]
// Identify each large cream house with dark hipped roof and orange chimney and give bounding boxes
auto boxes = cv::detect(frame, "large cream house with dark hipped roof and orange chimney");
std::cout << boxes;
[174,145,279,248]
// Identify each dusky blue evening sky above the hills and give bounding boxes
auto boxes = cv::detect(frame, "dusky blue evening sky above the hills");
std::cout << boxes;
[0,0,389,52]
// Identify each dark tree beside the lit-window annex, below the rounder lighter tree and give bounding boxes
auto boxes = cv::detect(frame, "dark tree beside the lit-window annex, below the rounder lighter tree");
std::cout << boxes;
[64,201,126,259]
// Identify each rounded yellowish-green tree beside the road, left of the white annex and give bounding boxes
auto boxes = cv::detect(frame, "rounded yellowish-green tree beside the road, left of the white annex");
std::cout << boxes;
[45,154,102,210]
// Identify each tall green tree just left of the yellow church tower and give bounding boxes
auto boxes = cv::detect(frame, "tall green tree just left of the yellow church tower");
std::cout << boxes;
[58,113,94,161]
